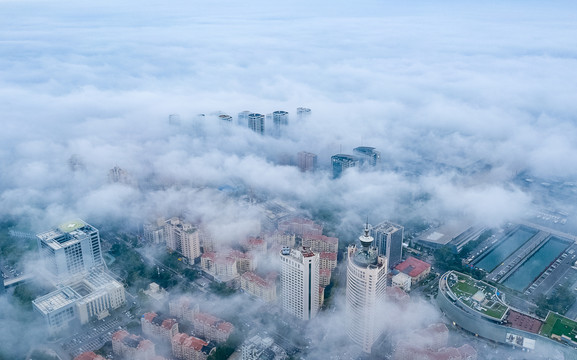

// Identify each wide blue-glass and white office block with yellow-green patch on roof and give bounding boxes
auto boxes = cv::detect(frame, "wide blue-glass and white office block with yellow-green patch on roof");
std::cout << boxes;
[36,219,104,281]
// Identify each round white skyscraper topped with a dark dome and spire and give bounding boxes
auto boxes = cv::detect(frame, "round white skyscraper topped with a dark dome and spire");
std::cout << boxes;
[345,224,387,353]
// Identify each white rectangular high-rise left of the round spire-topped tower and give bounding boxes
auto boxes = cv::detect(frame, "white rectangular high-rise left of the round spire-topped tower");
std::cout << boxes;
[280,247,319,320]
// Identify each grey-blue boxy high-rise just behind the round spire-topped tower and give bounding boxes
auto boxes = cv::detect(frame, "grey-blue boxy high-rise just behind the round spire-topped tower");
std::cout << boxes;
[371,221,405,269]
